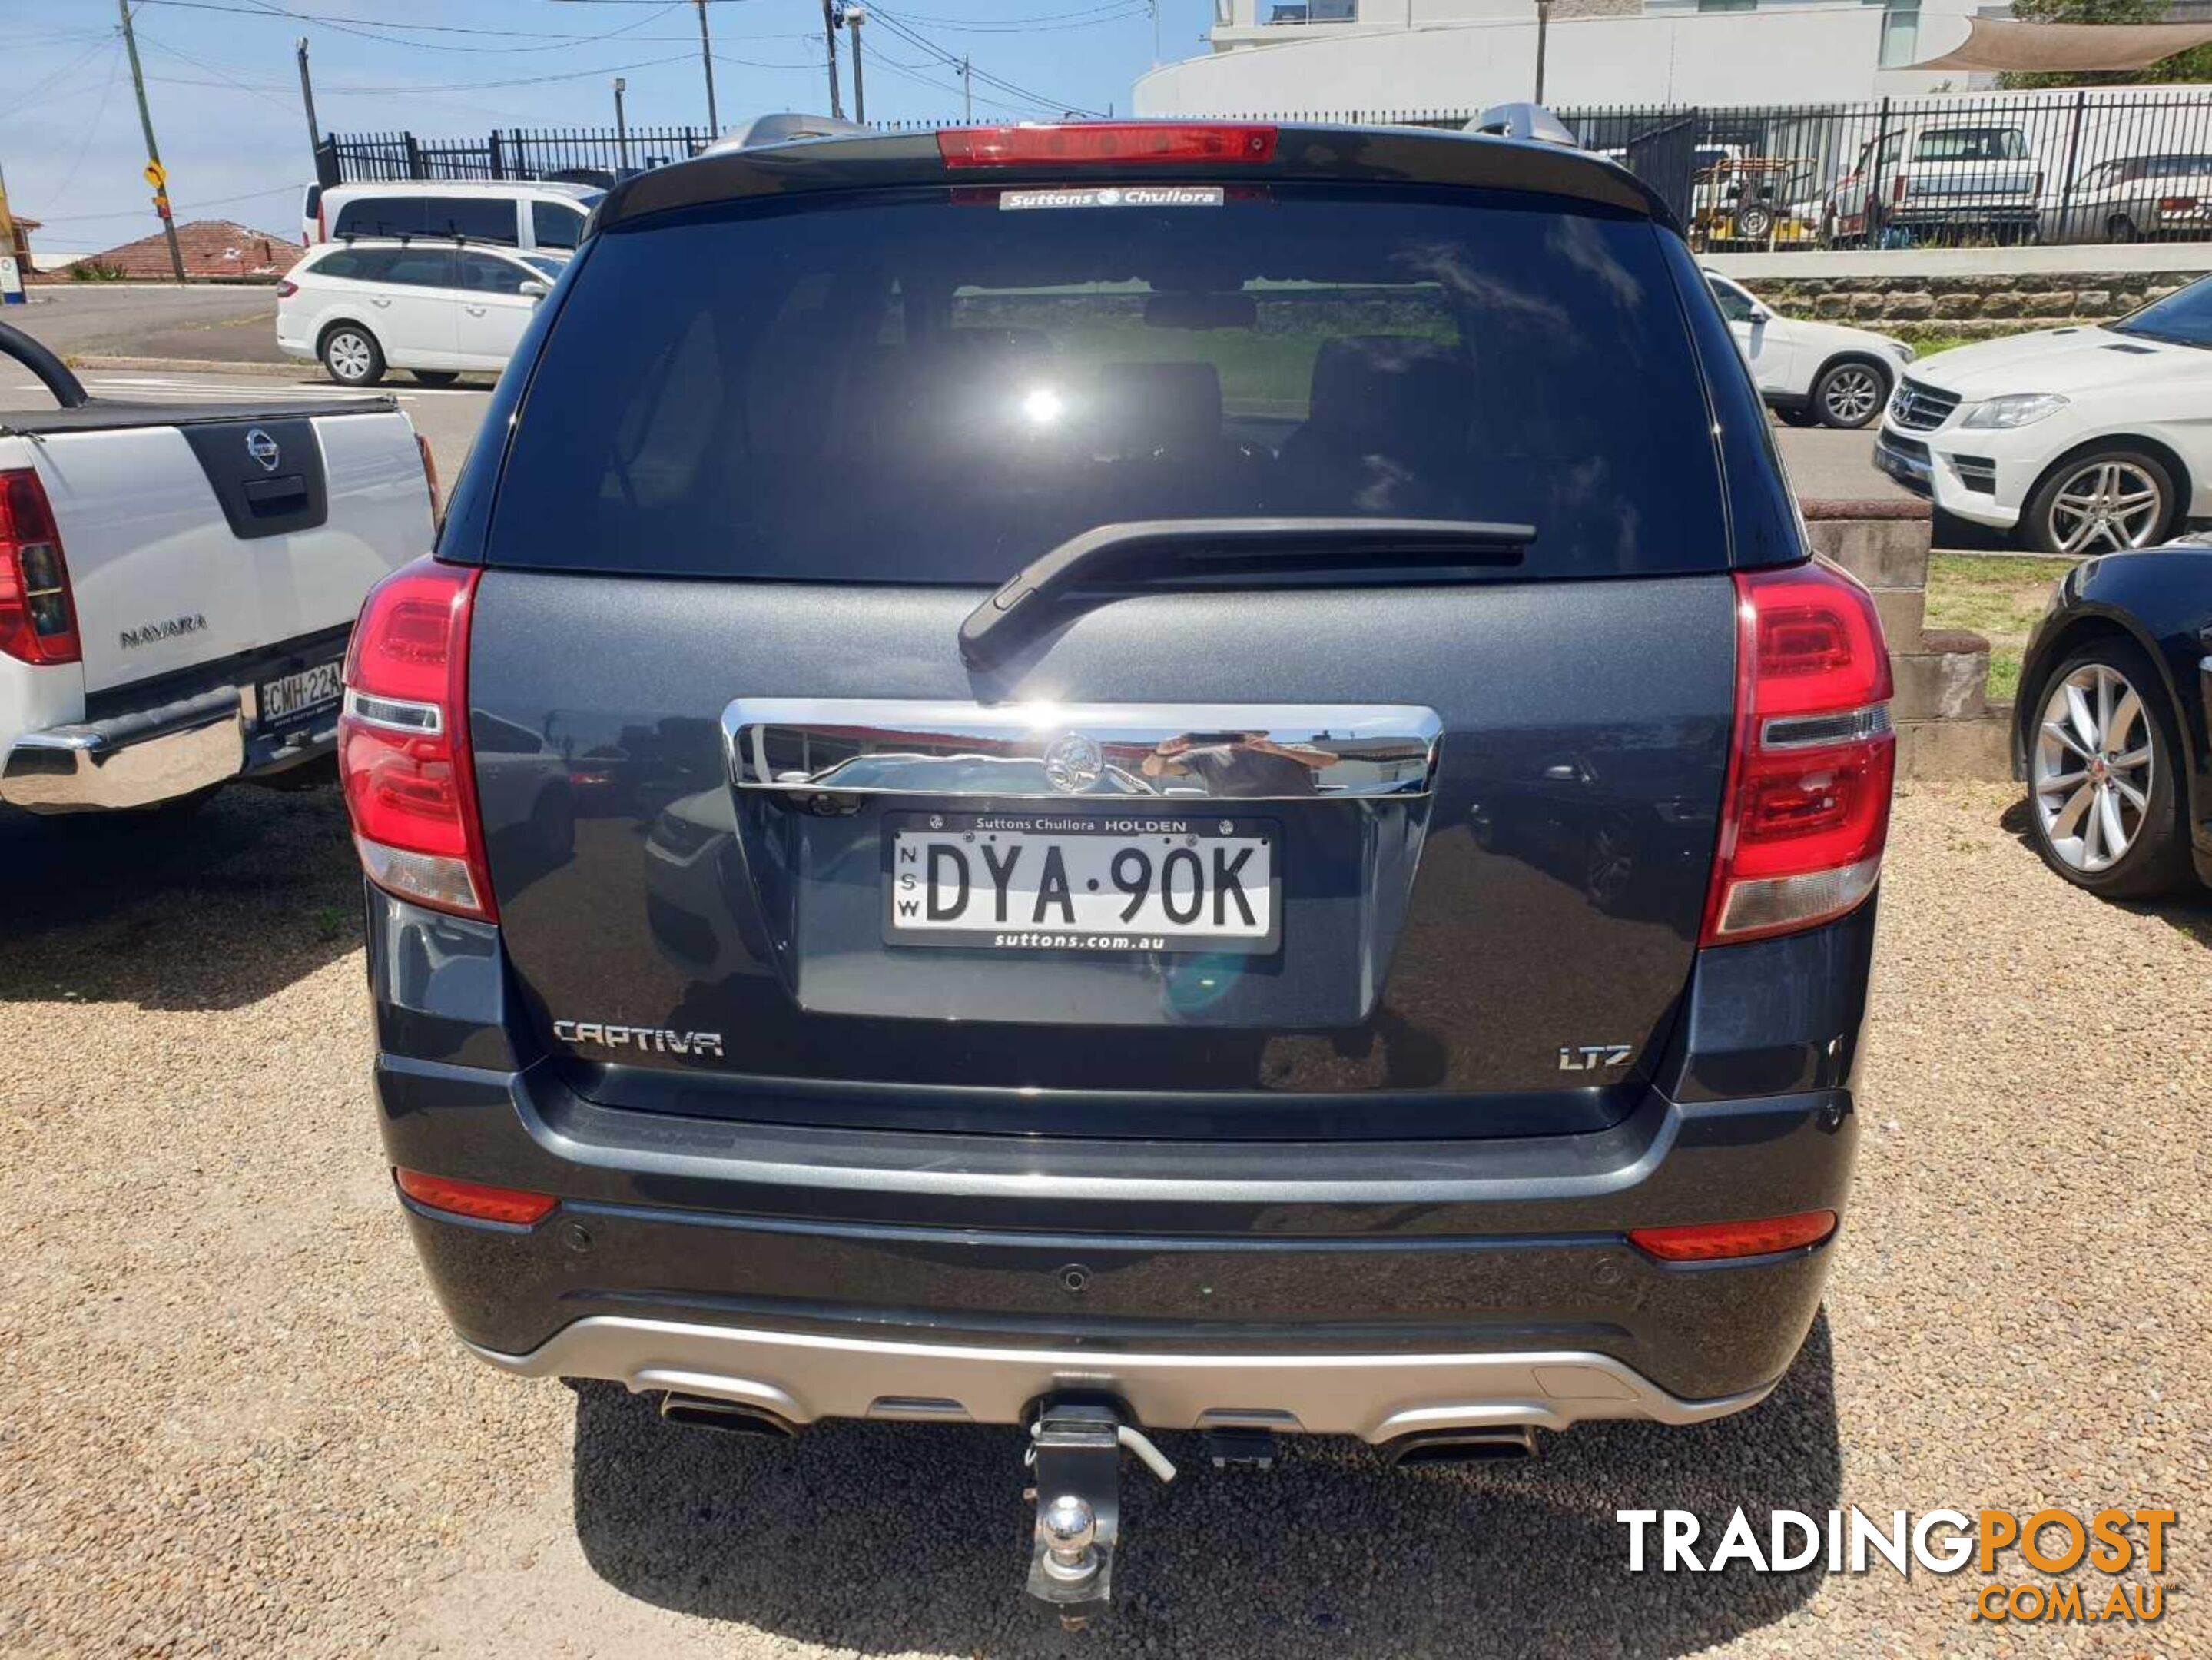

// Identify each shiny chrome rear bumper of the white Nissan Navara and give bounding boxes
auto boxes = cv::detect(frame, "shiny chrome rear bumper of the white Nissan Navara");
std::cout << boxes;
[0,686,246,812]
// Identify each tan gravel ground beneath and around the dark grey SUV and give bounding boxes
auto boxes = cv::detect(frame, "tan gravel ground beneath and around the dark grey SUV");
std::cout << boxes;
[0,785,2212,1660]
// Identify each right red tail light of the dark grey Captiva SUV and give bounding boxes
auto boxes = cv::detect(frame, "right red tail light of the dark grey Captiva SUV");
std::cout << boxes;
[1701,563,1898,945]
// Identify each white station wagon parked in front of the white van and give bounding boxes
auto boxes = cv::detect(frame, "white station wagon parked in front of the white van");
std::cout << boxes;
[277,239,564,385]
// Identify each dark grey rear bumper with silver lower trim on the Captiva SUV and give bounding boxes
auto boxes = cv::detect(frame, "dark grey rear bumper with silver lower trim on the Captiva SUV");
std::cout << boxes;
[367,890,1875,1439]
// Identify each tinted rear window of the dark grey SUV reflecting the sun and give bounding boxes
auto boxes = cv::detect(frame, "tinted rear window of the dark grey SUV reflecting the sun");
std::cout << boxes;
[486,186,1727,584]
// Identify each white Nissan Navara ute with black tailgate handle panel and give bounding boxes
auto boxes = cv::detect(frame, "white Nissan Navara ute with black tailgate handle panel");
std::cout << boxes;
[0,325,433,812]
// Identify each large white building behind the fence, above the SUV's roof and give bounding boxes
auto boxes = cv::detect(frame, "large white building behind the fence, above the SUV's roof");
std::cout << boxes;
[1135,0,2011,120]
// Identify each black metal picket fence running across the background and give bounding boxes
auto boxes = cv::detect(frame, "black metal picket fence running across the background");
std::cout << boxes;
[317,86,2212,250]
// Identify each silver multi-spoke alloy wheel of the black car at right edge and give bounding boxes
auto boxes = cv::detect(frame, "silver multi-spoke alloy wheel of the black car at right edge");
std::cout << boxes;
[2028,662,2152,875]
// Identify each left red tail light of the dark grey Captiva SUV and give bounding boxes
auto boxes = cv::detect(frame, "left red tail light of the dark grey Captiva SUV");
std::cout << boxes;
[338,558,498,921]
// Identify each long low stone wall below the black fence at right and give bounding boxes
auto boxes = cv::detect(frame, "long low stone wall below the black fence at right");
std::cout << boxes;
[1749,272,2194,334]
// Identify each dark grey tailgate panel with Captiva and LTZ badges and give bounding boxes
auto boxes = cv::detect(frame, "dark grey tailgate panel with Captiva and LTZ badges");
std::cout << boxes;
[471,571,1734,1134]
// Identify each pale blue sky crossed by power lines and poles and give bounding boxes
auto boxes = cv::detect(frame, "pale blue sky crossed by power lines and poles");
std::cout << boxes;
[0,0,1212,252]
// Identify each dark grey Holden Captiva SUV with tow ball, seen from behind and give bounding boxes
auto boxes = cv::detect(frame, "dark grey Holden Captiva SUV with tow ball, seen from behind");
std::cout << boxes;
[343,124,1893,1614]
